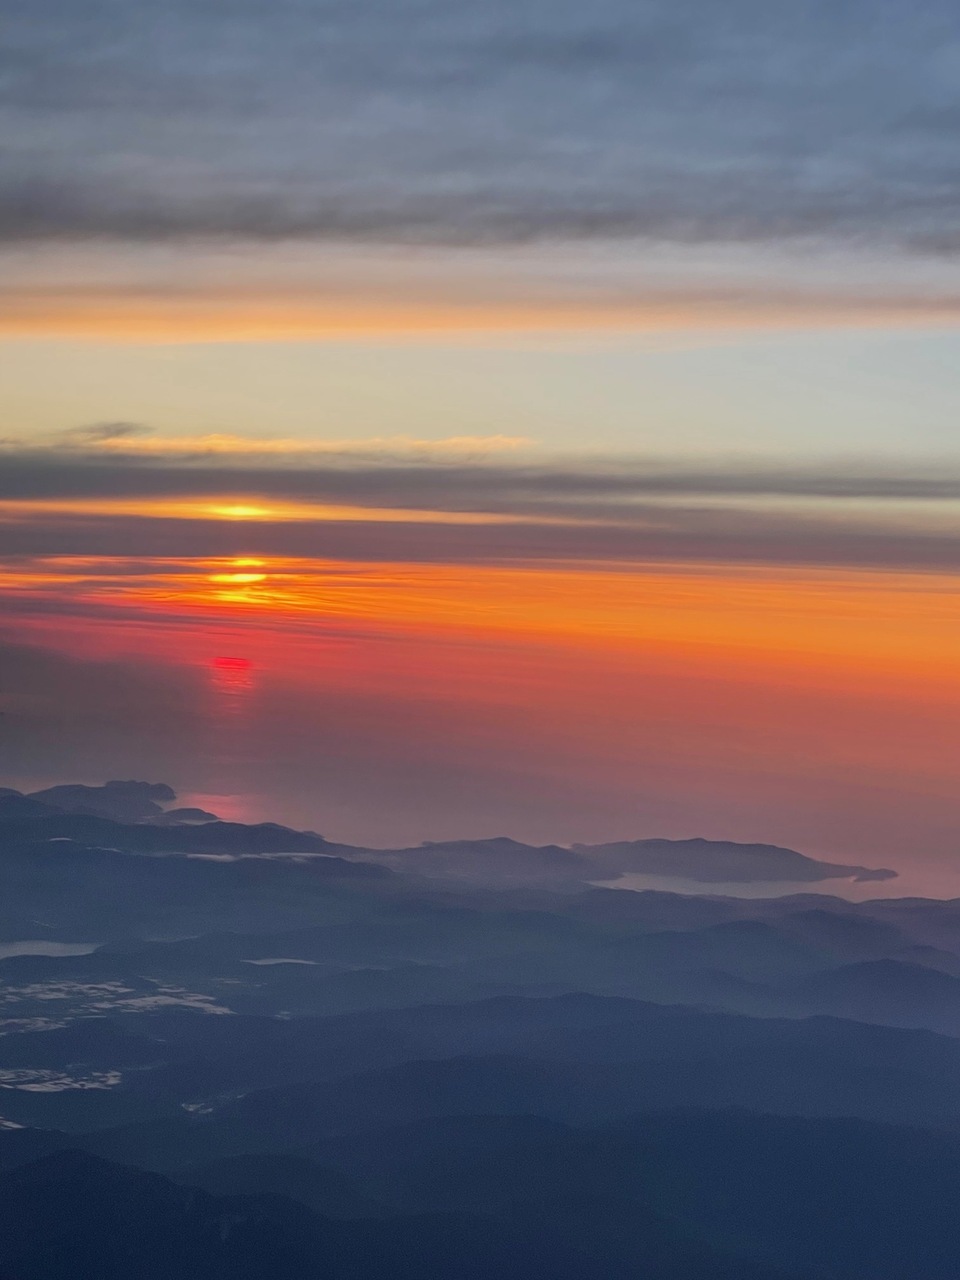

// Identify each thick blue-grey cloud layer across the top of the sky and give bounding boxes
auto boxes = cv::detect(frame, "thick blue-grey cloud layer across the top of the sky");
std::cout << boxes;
[0,0,960,255]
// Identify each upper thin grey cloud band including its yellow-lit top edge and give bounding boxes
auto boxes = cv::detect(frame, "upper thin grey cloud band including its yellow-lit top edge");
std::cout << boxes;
[9,440,960,499]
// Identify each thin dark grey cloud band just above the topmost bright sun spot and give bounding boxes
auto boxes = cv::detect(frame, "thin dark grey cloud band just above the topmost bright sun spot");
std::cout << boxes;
[0,453,960,506]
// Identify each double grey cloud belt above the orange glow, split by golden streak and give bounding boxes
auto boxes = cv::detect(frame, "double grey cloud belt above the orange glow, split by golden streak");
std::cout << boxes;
[0,453,960,571]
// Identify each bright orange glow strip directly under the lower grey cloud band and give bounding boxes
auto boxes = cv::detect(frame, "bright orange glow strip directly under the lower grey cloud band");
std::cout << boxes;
[0,557,960,696]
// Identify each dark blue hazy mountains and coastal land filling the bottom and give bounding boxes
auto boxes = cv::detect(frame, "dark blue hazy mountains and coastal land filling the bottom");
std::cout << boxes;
[0,782,960,1280]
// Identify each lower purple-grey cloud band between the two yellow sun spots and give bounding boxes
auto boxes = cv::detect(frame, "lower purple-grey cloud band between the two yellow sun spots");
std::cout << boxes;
[0,509,960,573]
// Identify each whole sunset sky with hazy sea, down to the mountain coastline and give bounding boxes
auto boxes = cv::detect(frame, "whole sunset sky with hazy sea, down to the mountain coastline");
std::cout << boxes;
[0,0,960,892]
